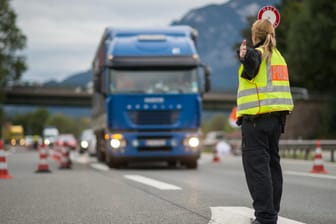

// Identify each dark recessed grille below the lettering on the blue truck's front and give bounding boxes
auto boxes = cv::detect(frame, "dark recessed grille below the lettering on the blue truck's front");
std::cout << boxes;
[128,110,180,125]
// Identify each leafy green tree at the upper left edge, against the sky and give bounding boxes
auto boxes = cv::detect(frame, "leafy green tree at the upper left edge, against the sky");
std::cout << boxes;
[0,0,27,88]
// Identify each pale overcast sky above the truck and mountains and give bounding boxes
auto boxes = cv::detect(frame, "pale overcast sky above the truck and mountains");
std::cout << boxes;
[11,0,228,82]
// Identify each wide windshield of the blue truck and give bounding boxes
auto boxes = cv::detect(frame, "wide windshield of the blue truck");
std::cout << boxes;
[109,68,199,94]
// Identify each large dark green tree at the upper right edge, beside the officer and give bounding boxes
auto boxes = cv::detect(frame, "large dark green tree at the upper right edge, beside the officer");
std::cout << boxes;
[286,0,336,93]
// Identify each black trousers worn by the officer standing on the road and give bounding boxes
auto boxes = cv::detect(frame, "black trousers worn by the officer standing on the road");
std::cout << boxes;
[242,116,283,224]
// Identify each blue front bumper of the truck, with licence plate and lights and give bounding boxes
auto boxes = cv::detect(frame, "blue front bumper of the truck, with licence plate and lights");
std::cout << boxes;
[107,132,201,161]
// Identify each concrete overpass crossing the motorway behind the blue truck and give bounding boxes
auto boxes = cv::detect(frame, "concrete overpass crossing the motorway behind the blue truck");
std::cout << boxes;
[4,86,236,111]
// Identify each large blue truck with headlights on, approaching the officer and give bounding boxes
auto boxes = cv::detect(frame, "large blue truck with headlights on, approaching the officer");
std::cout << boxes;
[92,26,210,169]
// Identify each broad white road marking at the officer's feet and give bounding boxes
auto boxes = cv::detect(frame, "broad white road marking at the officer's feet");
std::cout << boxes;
[208,207,305,224]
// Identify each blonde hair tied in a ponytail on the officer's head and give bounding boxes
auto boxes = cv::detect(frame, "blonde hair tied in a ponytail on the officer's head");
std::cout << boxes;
[252,19,276,62]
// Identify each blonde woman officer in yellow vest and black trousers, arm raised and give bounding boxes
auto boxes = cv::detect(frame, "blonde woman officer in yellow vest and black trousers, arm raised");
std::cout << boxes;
[237,20,294,224]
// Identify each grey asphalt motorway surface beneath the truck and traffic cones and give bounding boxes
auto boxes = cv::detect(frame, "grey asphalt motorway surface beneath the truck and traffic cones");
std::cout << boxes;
[0,148,336,224]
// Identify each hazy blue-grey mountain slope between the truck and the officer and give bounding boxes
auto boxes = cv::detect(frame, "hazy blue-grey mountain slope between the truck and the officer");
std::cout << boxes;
[172,0,279,91]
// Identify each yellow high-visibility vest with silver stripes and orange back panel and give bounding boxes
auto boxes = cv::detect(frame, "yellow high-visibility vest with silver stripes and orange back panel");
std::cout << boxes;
[237,48,294,117]
